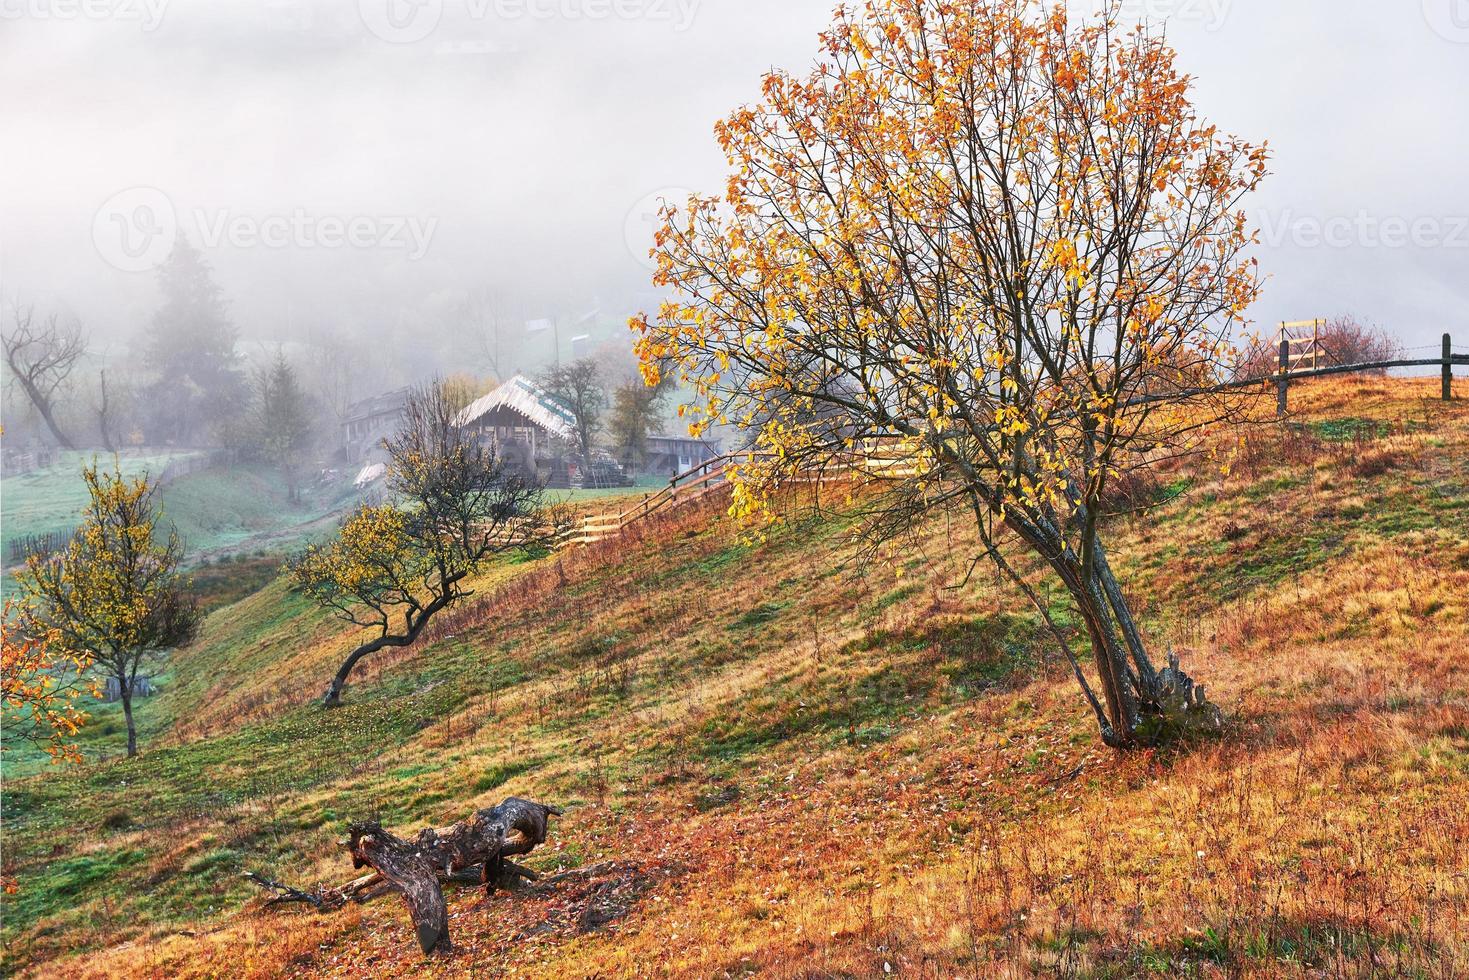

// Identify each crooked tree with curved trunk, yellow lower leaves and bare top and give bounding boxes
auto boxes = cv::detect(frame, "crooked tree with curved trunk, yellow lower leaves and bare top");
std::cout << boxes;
[286,382,546,707]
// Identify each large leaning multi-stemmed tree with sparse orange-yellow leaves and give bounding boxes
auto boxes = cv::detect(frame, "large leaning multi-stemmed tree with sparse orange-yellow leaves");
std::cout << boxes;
[633,0,1266,748]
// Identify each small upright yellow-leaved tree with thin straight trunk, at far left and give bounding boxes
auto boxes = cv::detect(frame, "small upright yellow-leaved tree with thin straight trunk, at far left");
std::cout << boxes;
[18,464,200,757]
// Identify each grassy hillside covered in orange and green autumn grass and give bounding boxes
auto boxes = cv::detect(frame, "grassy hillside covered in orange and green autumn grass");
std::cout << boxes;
[0,381,1469,977]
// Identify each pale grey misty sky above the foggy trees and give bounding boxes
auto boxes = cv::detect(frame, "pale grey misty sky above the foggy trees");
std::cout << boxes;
[0,0,1469,359]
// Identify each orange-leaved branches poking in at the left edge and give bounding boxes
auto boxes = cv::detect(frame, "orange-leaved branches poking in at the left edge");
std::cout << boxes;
[0,599,95,763]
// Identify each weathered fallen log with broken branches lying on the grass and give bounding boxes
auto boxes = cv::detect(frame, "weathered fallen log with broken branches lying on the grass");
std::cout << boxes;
[245,796,563,954]
